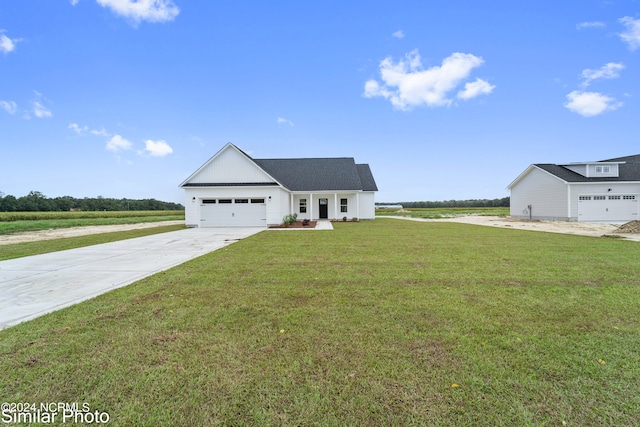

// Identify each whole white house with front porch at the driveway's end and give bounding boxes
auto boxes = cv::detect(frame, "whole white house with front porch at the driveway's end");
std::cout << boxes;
[180,143,378,227]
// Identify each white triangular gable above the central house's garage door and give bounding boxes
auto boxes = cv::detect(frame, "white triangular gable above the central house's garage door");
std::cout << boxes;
[181,144,278,187]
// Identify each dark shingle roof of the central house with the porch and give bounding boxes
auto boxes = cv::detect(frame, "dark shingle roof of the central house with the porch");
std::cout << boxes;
[252,156,378,191]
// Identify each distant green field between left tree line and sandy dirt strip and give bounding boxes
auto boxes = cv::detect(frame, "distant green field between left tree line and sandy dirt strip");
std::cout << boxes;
[0,211,184,235]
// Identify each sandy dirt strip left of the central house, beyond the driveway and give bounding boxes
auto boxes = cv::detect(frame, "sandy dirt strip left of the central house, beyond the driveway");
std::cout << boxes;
[0,221,184,245]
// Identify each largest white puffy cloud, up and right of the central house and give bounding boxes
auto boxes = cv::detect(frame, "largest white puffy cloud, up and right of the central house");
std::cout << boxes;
[363,50,493,110]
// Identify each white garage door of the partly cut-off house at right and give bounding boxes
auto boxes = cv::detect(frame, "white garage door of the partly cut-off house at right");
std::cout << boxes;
[578,194,638,222]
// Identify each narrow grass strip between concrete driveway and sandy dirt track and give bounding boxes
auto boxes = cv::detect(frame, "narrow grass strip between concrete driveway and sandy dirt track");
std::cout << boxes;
[0,224,185,261]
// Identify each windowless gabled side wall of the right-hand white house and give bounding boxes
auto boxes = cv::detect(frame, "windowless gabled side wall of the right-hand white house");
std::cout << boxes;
[510,167,570,220]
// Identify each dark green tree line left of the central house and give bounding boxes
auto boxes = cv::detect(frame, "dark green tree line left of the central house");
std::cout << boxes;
[0,191,184,212]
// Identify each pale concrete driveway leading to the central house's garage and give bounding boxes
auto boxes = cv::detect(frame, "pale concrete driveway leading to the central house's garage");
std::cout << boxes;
[0,227,264,329]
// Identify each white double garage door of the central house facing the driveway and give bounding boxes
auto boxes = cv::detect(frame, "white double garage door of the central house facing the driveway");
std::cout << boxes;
[200,198,267,227]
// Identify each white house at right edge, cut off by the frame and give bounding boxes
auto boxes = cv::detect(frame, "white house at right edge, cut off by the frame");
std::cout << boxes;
[508,155,640,222]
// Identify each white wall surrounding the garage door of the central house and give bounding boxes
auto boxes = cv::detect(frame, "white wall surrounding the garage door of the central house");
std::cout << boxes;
[184,187,289,227]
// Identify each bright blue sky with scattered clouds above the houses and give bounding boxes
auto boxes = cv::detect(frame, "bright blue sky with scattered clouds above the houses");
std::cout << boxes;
[0,0,640,203]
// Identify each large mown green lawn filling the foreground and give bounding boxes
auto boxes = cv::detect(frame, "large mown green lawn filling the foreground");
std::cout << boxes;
[0,219,640,426]
